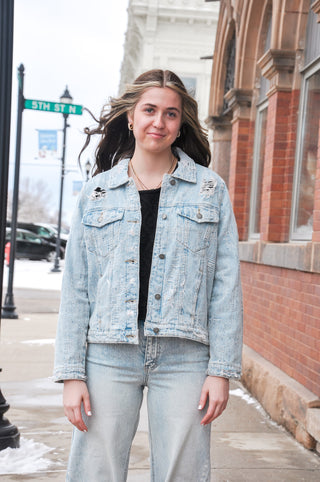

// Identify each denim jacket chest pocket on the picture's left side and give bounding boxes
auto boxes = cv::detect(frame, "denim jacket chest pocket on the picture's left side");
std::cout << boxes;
[82,209,124,256]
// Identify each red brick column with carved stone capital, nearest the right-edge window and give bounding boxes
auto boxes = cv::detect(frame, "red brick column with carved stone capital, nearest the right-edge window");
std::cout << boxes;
[258,49,300,242]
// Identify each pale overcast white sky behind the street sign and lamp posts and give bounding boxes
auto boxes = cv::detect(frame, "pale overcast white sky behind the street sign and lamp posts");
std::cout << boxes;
[9,0,128,225]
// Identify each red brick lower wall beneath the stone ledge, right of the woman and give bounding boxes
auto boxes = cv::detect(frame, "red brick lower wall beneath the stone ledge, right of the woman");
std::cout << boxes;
[241,262,320,397]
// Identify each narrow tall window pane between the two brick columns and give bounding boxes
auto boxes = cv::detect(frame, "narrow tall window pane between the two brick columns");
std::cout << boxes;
[249,101,268,238]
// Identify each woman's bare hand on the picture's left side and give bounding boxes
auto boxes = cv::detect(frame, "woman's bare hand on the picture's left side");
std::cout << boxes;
[63,380,91,432]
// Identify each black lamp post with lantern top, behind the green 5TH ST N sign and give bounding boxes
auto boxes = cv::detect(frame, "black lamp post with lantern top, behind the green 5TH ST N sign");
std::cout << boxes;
[51,86,73,273]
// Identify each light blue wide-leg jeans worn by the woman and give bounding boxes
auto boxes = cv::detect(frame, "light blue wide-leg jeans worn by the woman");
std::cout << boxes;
[66,323,211,482]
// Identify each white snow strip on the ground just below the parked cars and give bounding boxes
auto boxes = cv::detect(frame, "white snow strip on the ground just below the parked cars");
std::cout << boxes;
[3,259,64,291]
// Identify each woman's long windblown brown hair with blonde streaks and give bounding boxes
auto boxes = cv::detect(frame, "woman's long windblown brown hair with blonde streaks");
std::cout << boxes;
[79,69,211,175]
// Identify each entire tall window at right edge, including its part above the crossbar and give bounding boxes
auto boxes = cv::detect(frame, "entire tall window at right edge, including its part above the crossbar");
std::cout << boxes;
[290,1,320,241]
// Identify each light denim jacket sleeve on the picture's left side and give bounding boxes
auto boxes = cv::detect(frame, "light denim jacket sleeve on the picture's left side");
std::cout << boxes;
[53,187,90,382]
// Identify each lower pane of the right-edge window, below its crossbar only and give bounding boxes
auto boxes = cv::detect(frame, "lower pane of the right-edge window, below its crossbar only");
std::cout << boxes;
[291,64,320,240]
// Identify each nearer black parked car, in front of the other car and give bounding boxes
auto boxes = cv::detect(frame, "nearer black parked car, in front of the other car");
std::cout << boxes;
[6,228,64,261]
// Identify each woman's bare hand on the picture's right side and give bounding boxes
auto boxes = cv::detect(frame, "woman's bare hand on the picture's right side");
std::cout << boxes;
[198,376,229,425]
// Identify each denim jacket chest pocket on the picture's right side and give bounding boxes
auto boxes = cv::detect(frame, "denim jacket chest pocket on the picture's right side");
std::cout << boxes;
[177,206,219,252]
